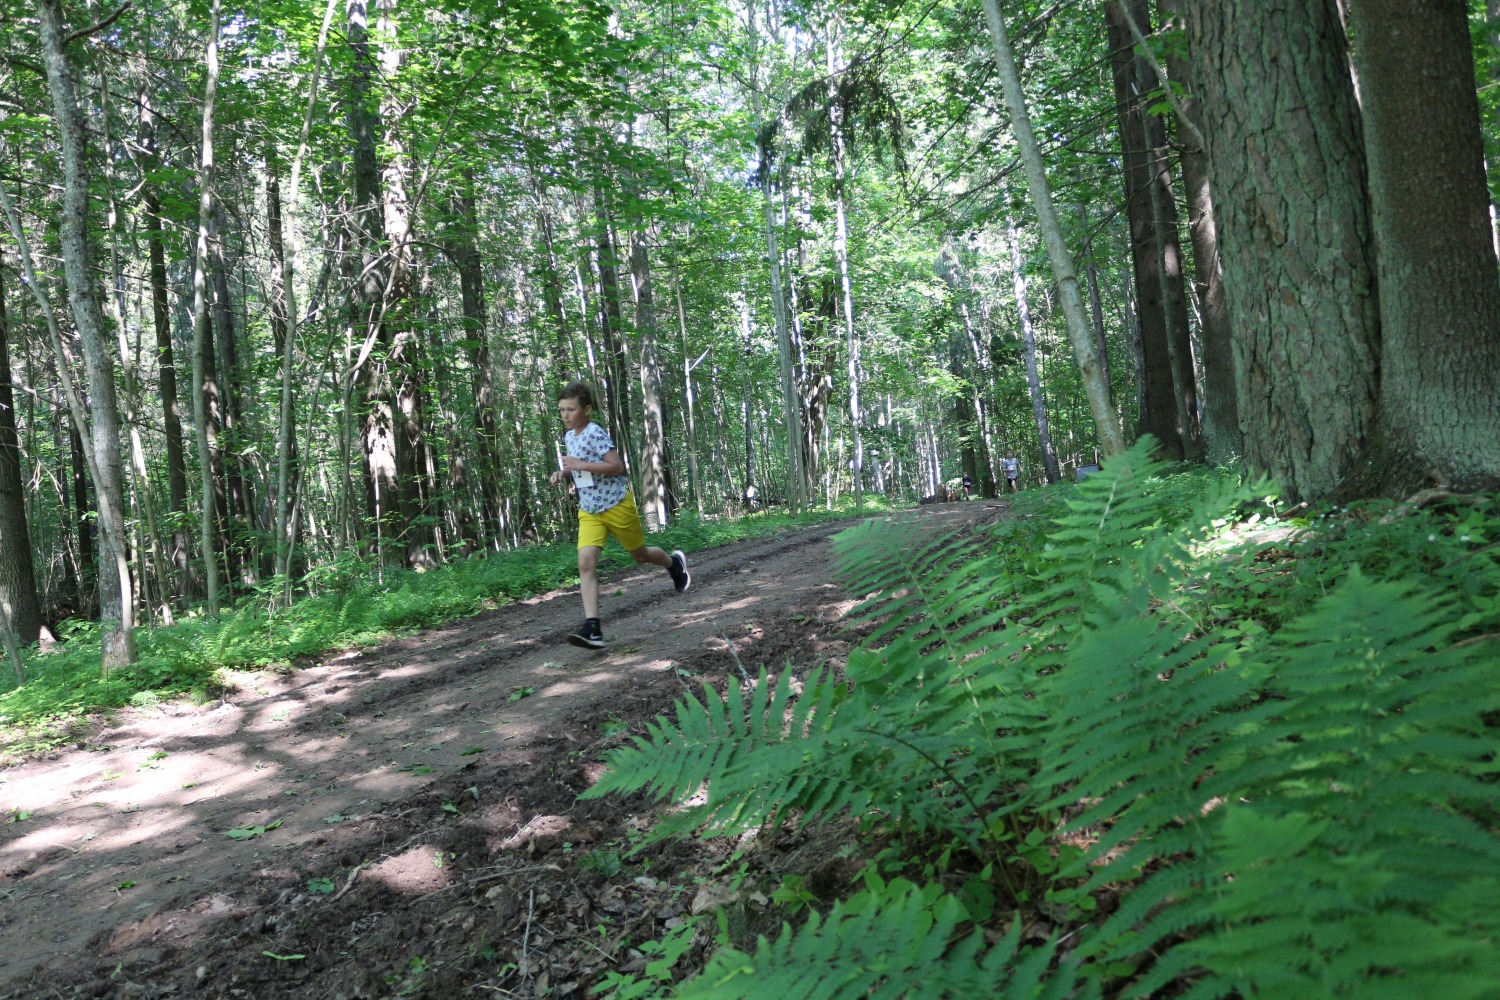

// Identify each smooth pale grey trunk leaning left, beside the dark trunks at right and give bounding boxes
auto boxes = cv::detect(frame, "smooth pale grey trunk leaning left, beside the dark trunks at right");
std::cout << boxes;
[981,0,1125,459]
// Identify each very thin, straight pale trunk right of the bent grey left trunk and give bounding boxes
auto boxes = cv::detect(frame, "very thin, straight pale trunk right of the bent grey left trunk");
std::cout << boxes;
[192,0,219,618]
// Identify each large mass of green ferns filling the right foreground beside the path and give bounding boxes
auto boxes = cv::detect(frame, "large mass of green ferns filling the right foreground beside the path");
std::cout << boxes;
[585,444,1500,1000]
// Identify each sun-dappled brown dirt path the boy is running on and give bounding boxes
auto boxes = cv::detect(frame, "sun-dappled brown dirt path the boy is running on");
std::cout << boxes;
[0,504,998,1000]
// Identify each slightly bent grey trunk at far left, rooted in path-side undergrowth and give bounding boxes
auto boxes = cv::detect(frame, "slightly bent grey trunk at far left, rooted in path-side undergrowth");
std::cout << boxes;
[41,0,135,669]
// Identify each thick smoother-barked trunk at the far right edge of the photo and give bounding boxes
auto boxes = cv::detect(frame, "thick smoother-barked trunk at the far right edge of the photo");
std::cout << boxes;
[1349,0,1500,496]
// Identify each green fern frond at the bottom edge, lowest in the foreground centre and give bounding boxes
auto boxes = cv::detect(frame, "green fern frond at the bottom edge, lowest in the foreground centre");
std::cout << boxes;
[677,879,1098,1000]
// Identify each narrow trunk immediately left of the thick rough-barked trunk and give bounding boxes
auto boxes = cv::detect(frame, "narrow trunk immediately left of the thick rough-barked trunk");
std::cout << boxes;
[1157,0,1245,465]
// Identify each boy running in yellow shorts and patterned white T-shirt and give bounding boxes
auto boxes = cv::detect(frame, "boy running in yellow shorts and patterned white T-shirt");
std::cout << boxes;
[552,382,693,649]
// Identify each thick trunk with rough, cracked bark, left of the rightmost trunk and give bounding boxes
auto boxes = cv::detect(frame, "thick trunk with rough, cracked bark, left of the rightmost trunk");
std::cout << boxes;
[1188,0,1380,498]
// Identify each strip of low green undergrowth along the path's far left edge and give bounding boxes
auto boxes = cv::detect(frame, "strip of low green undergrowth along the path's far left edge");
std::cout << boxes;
[0,498,885,756]
